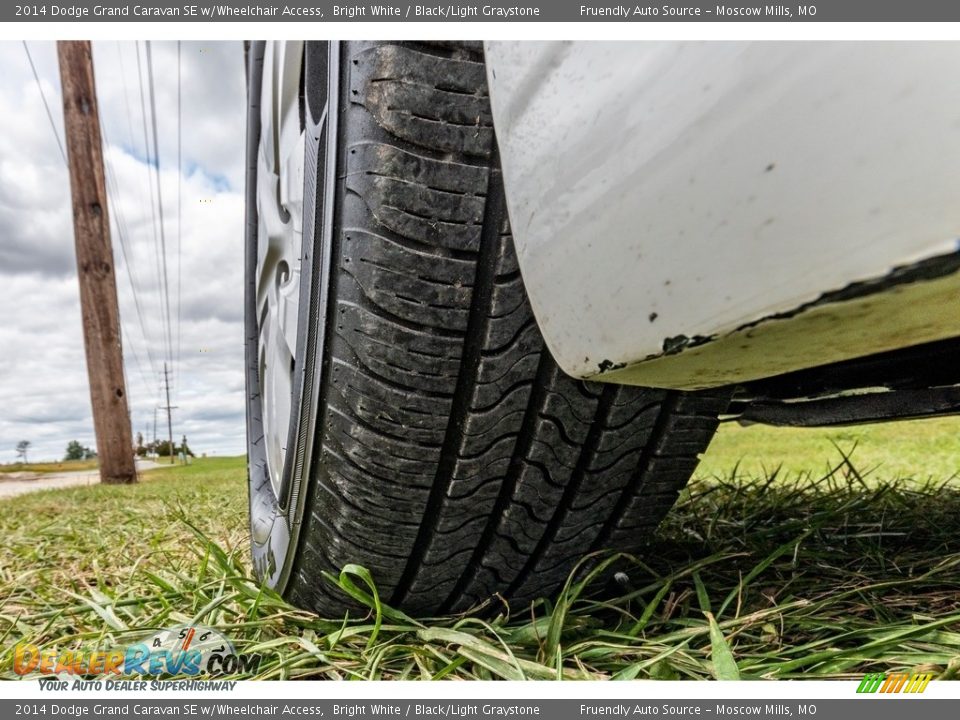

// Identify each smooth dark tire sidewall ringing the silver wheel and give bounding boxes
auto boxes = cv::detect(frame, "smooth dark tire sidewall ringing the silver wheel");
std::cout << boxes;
[244,42,340,592]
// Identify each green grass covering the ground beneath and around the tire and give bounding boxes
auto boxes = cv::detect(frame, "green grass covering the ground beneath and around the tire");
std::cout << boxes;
[0,434,960,679]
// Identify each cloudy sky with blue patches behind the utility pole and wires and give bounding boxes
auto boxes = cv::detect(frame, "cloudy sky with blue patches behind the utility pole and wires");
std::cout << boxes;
[0,41,245,462]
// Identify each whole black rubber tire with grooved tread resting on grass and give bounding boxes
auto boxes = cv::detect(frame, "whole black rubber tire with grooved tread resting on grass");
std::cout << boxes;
[247,42,728,615]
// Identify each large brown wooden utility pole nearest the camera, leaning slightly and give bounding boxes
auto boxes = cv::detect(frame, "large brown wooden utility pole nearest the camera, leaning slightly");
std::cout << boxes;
[57,41,137,483]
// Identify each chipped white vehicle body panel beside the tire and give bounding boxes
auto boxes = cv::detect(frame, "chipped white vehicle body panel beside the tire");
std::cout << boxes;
[486,42,960,388]
